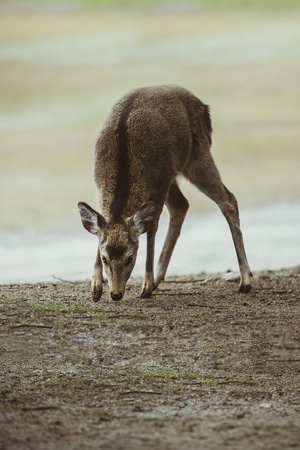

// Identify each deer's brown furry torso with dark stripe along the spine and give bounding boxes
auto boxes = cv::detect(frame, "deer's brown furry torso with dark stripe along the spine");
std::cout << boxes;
[94,86,211,219]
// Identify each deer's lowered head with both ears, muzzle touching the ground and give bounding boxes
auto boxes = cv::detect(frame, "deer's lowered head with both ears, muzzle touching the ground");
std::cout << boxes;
[78,202,155,300]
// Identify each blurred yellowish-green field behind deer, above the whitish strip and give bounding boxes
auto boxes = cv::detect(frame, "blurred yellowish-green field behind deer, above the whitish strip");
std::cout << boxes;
[0,0,300,231]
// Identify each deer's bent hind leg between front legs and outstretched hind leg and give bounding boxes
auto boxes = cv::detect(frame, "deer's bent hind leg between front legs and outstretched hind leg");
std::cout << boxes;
[155,181,189,287]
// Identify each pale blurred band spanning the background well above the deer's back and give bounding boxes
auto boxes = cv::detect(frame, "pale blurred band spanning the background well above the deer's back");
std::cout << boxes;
[0,23,300,67]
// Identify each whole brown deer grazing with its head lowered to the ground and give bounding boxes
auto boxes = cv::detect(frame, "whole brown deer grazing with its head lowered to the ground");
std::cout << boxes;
[78,85,252,302]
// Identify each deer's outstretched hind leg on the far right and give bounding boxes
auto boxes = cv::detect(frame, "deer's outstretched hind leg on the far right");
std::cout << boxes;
[184,148,252,293]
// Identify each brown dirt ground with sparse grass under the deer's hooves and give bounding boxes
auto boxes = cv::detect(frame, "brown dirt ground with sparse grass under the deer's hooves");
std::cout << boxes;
[0,267,300,450]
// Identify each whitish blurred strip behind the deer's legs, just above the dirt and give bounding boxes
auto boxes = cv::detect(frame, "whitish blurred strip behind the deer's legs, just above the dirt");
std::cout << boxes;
[0,204,300,283]
